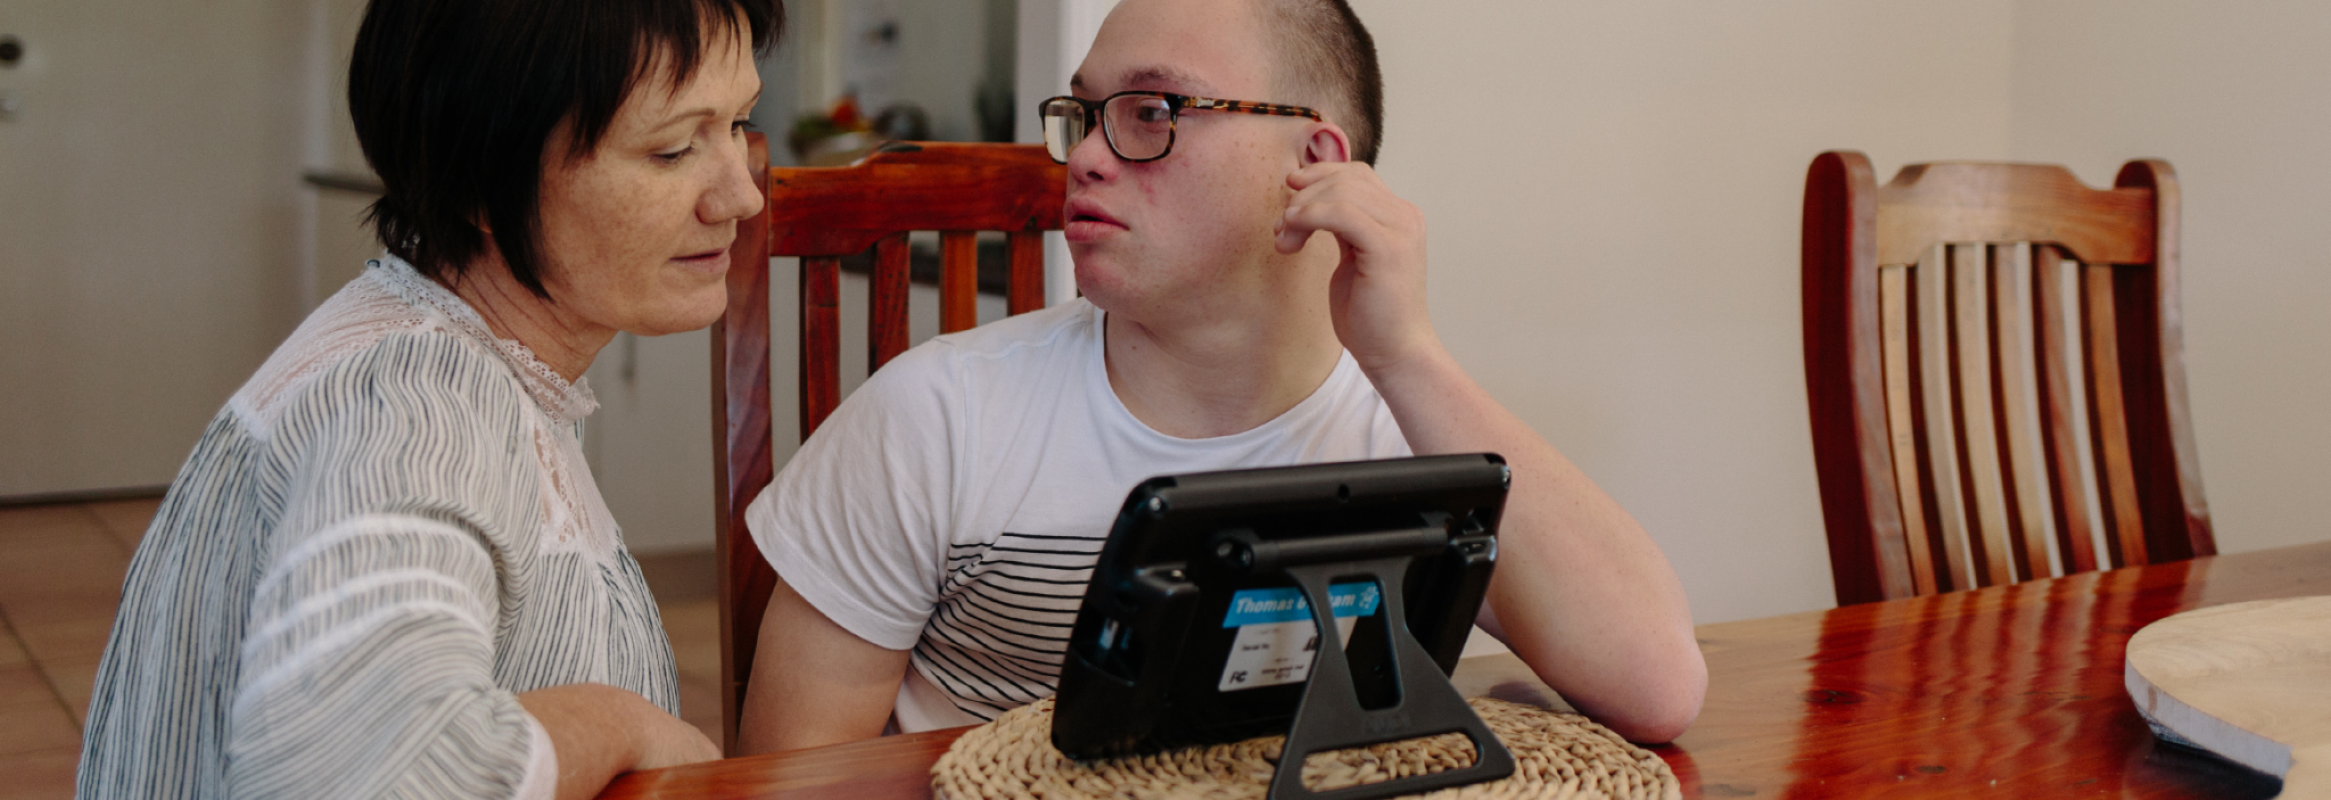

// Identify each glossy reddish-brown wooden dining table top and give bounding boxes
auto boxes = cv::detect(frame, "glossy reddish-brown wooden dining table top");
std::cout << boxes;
[601,541,2331,798]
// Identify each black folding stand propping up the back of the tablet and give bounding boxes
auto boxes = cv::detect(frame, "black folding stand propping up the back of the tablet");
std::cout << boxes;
[1210,527,1513,800]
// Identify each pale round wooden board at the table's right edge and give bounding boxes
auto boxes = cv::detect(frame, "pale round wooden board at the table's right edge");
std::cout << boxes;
[2126,597,2331,798]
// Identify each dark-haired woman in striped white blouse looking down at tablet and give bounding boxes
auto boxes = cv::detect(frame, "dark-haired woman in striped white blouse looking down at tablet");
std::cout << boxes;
[79,0,783,798]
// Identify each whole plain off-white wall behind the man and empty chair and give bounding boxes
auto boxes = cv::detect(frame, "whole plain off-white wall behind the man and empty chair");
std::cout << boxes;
[1354,0,2331,623]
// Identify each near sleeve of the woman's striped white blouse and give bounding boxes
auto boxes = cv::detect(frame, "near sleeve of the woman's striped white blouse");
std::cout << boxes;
[226,334,557,798]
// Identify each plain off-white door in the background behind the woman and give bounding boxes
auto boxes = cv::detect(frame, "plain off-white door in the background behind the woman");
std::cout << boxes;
[0,0,308,497]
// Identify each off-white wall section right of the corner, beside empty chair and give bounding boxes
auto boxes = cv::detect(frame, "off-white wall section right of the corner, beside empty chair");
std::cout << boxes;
[2009,0,2331,553]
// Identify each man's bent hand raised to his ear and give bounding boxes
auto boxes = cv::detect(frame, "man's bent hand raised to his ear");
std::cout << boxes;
[1277,161,1441,373]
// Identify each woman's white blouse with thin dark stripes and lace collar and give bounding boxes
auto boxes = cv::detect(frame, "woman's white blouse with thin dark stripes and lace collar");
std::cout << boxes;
[79,257,678,798]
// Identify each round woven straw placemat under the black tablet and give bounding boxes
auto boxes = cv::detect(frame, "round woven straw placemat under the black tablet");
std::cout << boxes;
[930,697,1683,800]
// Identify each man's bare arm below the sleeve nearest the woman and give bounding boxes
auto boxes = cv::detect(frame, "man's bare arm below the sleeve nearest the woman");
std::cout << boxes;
[737,578,909,756]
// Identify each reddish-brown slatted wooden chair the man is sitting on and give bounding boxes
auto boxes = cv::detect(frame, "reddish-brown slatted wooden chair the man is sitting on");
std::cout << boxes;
[711,133,1068,749]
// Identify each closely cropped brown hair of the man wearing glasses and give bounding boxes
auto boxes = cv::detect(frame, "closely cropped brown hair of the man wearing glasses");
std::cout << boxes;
[1256,0,1385,166]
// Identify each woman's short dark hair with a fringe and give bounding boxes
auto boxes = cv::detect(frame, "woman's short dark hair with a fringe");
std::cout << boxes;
[347,0,786,299]
